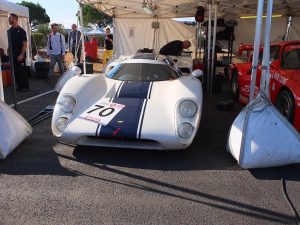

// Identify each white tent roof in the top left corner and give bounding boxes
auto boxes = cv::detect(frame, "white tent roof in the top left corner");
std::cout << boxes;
[0,0,29,17]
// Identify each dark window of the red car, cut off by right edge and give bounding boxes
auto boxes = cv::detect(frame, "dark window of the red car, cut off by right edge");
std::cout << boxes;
[281,45,300,69]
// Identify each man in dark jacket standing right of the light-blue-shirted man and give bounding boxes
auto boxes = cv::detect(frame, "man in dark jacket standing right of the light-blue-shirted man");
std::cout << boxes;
[68,24,81,63]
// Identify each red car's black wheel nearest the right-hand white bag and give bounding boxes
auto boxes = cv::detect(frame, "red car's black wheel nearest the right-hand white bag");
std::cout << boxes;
[275,90,295,124]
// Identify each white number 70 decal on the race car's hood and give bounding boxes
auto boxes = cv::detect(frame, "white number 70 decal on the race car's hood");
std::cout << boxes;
[80,101,125,126]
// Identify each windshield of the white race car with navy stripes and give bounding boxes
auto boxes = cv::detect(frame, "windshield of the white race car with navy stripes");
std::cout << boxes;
[106,63,179,81]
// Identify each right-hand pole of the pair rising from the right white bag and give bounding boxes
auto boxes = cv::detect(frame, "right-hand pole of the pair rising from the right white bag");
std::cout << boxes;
[260,0,273,98]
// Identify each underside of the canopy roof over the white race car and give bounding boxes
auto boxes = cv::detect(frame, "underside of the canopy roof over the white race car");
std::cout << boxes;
[77,0,300,18]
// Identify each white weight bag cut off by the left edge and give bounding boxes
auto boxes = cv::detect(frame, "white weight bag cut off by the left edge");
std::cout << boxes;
[0,101,32,159]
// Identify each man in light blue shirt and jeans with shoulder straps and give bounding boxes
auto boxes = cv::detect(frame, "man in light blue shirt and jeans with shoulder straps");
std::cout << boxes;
[47,23,66,83]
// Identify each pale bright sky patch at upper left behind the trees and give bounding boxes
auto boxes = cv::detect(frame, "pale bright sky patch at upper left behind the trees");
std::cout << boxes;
[8,0,79,28]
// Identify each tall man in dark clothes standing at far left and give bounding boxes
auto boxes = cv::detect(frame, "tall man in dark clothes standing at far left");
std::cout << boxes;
[8,13,29,92]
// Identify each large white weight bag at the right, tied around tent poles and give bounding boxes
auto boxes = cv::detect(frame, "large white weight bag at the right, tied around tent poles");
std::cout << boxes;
[227,93,300,169]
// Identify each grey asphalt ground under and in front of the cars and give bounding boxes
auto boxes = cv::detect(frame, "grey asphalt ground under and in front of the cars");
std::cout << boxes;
[0,73,300,225]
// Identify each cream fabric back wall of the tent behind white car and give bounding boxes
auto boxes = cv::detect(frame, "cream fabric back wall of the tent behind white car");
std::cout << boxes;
[114,18,195,57]
